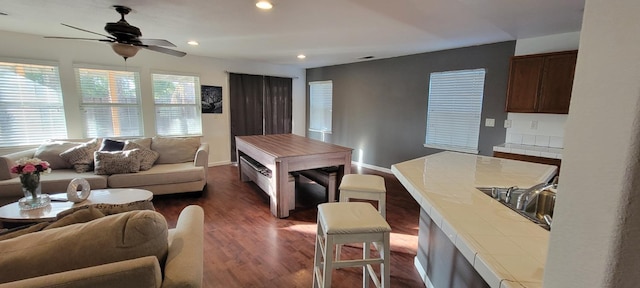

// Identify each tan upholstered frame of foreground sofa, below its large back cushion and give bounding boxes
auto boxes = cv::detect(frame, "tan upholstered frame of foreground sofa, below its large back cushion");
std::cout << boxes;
[0,256,162,288]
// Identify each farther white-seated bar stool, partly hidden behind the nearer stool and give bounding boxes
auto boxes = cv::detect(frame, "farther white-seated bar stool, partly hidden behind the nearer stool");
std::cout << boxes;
[338,174,387,218]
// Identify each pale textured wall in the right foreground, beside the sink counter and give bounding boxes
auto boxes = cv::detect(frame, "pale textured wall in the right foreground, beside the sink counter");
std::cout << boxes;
[544,0,640,288]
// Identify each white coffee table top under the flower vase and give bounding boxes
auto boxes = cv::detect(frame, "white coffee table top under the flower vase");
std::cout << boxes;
[0,188,153,223]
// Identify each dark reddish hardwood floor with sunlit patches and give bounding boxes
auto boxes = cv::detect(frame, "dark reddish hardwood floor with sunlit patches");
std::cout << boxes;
[153,165,424,287]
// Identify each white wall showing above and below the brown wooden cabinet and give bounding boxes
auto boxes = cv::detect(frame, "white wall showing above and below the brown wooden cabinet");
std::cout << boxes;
[505,32,580,148]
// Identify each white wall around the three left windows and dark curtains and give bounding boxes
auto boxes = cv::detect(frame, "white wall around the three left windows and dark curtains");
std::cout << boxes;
[0,31,306,165]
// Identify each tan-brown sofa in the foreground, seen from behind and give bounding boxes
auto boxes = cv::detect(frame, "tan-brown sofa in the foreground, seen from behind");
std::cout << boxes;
[0,205,204,288]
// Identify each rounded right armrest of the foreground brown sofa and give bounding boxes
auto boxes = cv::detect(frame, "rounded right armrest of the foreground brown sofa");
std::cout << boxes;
[162,205,204,287]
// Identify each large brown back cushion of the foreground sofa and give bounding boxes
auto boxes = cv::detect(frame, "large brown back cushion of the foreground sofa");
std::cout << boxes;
[0,210,168,283]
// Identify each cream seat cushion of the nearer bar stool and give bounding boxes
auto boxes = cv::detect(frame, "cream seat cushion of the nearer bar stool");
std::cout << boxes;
[318,202,391,234]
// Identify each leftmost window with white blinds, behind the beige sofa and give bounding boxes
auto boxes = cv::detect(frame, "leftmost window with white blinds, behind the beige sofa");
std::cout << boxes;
[0,62,67,147]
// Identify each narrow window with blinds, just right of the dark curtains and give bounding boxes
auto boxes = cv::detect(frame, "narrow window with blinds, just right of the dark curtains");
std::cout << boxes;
[309,81,333,141]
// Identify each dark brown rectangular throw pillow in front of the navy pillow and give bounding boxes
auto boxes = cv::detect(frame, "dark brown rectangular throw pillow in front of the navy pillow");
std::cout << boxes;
[94,149,140,175]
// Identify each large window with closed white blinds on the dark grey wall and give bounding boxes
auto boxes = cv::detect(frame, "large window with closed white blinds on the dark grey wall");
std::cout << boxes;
[425,69,485,154]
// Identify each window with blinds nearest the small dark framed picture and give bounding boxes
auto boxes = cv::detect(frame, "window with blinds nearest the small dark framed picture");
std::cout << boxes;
[152,74,202,136]
